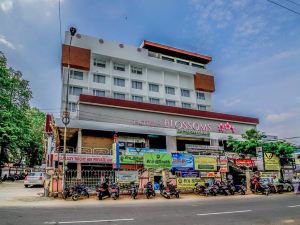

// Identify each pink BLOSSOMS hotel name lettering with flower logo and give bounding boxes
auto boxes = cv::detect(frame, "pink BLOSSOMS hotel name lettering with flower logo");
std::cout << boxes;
[132,119,236,135]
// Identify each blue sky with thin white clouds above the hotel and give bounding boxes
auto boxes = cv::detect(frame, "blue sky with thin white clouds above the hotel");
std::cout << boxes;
[0,0,300,145]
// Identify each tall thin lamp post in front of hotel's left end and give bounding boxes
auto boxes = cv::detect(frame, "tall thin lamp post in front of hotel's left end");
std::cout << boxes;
[62,27,76,191]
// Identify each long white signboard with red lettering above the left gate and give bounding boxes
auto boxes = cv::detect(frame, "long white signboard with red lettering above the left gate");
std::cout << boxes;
[53,153,112,164]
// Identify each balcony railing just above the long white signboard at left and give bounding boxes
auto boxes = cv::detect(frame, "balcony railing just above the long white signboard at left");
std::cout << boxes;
[55,146,112,155]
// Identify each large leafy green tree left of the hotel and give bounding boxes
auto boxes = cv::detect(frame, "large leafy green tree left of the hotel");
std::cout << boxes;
[0,52,44,166]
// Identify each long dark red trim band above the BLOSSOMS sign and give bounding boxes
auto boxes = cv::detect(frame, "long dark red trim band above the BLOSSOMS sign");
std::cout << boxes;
[79,94,259,124]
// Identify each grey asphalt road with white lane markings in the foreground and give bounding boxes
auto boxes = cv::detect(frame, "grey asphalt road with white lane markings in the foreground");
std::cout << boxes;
[0,194,300,225]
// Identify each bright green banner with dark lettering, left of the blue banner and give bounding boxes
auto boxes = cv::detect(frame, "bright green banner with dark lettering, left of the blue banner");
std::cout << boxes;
[144,153,172,169]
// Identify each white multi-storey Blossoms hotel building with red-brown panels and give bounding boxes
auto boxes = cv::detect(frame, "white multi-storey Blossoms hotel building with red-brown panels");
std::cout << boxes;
[54,32,259,172]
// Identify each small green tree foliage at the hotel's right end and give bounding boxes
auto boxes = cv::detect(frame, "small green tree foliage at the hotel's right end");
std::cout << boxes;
[227,129,296,157]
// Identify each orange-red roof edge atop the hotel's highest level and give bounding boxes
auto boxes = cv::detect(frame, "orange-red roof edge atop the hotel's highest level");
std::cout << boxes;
[142,40,212,63]
